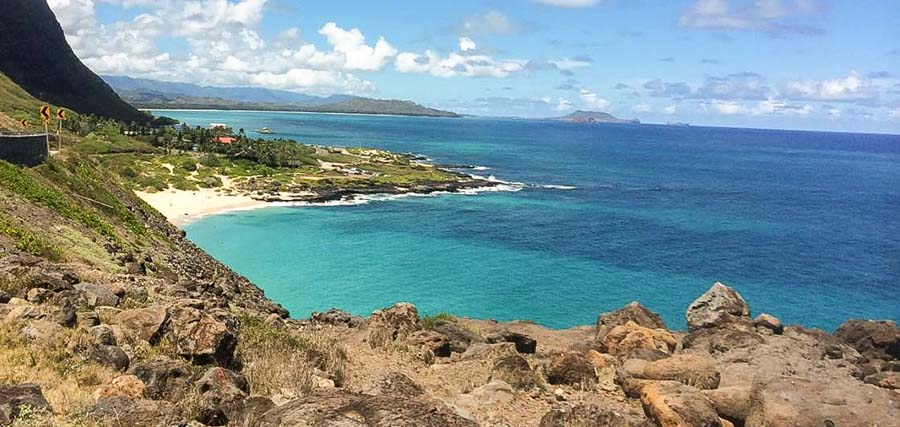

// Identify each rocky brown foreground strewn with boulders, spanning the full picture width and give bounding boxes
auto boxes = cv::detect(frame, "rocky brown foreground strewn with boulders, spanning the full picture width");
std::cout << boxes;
[0,255,900,427]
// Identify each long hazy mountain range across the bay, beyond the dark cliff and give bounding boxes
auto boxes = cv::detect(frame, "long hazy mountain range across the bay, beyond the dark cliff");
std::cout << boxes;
[103,76,459,117]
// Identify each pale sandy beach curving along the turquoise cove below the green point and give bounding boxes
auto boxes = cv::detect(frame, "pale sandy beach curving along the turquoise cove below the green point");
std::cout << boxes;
[135,189,267,227]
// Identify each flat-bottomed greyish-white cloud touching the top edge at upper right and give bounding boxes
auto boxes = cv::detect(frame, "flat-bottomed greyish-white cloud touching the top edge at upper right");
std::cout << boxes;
[678,0,822,35]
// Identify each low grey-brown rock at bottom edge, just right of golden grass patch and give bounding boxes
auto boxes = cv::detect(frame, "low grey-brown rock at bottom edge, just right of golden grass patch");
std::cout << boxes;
[86,397,185,426]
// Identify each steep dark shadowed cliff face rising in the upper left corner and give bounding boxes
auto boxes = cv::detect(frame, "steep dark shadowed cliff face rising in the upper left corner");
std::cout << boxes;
[0,0,150,122]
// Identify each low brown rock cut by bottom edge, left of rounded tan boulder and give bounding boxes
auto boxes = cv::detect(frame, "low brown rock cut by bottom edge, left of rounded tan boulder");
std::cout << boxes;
[539,404,650,427]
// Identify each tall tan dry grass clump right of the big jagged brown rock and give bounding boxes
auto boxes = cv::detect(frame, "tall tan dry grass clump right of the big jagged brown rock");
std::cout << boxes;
[237,316,347,396]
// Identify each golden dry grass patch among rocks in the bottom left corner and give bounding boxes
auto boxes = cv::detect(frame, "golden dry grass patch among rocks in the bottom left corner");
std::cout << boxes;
[0,323,118,426]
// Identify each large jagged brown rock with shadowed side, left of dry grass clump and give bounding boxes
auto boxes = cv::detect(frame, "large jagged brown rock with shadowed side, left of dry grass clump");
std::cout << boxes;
[169,307,237,366]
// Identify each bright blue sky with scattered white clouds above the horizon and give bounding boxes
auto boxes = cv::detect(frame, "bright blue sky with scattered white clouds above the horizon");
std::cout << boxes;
[48,0,900,133]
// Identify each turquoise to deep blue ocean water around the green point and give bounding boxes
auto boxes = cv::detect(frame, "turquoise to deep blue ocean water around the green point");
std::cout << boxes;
[151,111,900,330]
